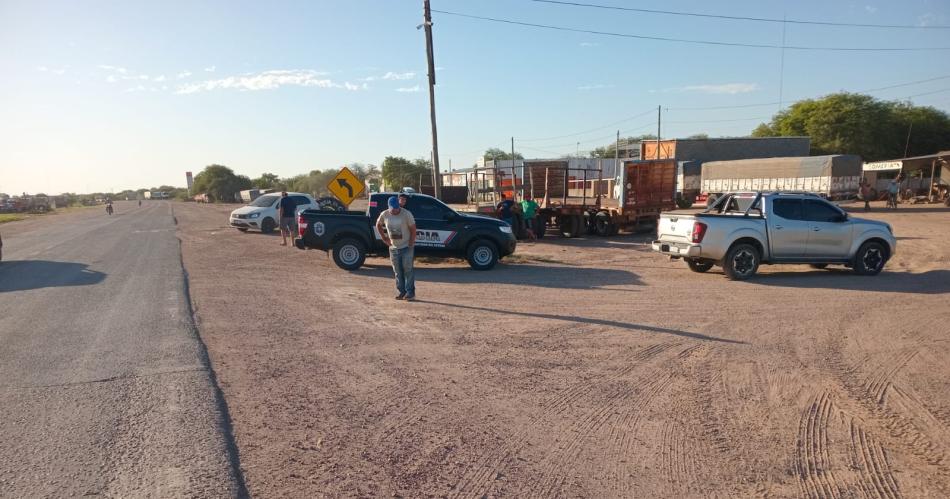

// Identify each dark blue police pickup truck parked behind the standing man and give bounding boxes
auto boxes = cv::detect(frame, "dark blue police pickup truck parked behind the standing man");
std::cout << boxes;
[296,192,517,270]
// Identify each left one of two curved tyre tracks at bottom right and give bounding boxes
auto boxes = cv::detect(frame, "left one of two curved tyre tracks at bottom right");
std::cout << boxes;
[795,392,841,499]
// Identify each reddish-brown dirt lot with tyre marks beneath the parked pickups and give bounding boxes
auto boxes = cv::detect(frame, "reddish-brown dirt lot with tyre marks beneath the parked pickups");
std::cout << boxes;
[175,201,950,498]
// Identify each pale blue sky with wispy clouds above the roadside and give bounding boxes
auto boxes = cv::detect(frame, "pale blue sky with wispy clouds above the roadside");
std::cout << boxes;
[0,0,950,194]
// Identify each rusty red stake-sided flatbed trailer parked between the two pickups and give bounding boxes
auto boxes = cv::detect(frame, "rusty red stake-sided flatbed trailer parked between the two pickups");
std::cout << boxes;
[469,160,676,237]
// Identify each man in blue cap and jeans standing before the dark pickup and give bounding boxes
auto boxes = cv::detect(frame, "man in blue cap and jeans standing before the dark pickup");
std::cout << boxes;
[376,197,416,301]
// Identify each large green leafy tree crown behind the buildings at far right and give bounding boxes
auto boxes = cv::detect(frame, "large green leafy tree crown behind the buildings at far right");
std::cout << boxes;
[752,93,950,161]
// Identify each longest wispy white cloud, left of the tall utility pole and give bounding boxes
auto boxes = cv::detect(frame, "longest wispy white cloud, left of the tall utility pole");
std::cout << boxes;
[175,69,365,94]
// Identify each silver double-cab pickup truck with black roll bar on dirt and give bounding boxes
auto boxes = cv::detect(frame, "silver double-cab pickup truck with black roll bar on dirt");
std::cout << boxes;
[653,192,897,280]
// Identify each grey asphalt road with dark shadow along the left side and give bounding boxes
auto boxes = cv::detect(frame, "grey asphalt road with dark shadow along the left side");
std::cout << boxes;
[0,202,245,497]
